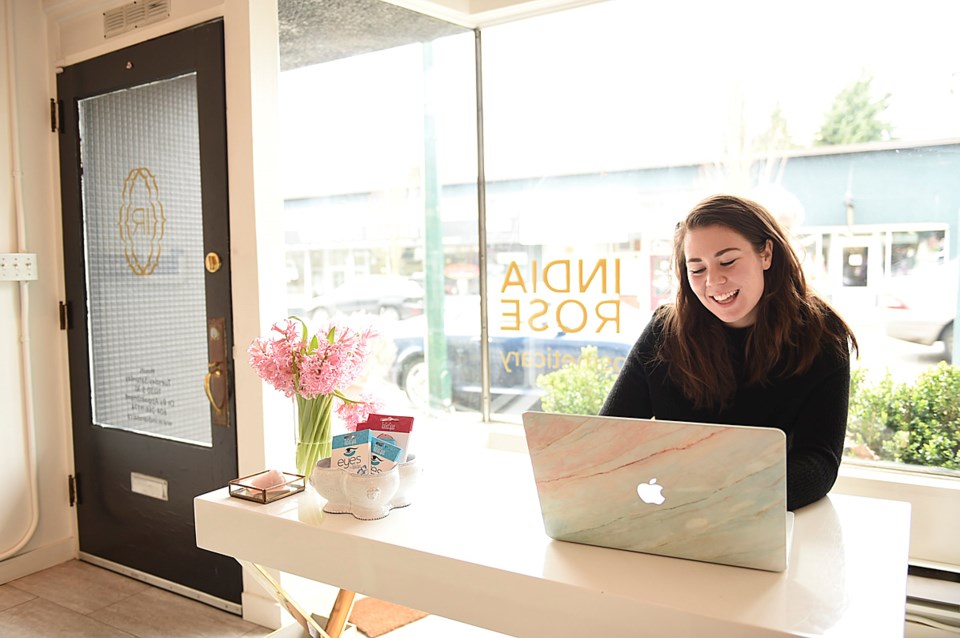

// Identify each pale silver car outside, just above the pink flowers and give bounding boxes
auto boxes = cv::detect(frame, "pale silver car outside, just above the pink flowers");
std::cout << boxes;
[303,275,423,324]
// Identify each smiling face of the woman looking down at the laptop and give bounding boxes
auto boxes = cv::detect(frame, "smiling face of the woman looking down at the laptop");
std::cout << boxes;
[683,226,773,328]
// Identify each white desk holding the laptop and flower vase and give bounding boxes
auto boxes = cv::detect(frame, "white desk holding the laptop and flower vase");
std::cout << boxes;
[194,427,910,638]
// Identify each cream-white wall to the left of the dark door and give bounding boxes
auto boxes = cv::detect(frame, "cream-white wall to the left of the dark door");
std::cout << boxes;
[0,0,76,582]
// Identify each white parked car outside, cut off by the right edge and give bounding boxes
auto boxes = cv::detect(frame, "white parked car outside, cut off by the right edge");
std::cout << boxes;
[883,260,960,363]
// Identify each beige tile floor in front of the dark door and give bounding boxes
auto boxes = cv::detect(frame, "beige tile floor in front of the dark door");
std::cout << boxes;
[0,560,270,638]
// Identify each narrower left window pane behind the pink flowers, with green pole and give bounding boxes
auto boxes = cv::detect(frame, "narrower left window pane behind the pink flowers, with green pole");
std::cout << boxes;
[280,0,480,414]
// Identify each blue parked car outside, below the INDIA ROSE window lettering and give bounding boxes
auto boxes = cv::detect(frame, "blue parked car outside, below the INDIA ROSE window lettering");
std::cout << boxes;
[390,305,639,413]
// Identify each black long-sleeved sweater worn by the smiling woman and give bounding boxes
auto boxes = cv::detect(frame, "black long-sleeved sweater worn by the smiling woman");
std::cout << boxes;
[600,313,850,510]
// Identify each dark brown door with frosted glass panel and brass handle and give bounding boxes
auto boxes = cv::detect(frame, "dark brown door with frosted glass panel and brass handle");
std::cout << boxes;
[57,21,241,603]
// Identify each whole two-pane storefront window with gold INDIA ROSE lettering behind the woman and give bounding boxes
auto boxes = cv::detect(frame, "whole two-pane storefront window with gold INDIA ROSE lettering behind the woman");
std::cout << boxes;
[281,0,960,480]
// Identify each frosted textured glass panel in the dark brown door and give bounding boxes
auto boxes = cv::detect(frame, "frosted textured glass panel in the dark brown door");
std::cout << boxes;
[79,74,212,446]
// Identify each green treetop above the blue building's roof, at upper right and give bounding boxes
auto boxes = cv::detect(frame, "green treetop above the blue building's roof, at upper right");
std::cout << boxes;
[814,73,891,146]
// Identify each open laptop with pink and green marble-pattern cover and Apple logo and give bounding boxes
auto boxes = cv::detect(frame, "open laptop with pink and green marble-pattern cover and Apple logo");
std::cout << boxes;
[522,411,793,572]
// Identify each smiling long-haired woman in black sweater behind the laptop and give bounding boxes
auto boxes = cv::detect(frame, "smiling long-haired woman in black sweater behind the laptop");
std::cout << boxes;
[600,195,857,510]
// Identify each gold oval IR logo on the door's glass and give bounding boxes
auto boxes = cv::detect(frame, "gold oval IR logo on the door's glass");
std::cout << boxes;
[120,167,167,277]
